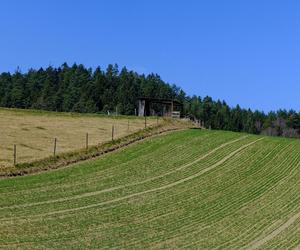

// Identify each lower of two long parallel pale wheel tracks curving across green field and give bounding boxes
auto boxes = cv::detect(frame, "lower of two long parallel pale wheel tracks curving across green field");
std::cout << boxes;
[1,138,264,221]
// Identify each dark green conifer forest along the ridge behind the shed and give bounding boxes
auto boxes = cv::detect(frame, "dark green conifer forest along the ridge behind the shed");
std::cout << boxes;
[0,63,300,137]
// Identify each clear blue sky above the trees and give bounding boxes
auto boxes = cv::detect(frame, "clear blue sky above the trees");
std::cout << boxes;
[0,0,300,111]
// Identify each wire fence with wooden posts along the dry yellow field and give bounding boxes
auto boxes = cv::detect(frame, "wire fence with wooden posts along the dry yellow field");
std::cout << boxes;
[0,117,159,167]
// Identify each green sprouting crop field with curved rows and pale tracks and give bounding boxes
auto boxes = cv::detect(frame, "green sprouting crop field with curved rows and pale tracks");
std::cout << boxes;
[0,129,300,249]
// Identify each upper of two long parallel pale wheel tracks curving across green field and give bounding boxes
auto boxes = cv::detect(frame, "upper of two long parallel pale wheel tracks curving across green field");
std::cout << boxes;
[0,136,249,210]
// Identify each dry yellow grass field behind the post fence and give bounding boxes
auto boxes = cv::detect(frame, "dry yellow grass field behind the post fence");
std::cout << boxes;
[0,109,157,167]
